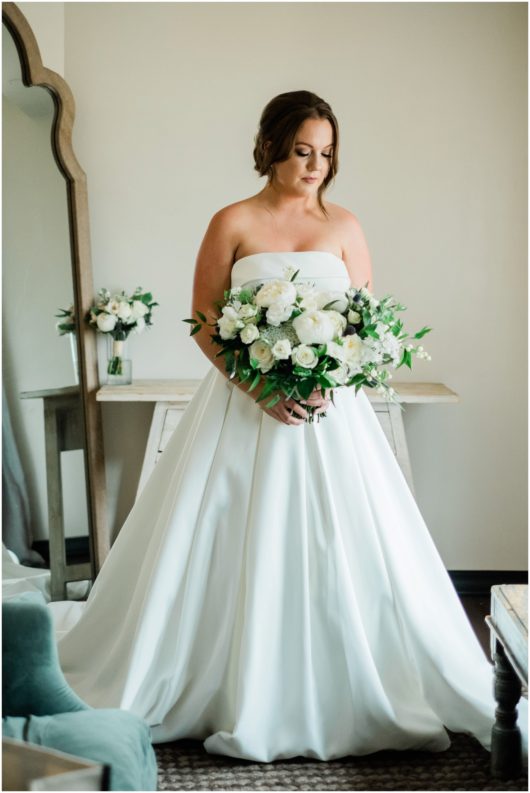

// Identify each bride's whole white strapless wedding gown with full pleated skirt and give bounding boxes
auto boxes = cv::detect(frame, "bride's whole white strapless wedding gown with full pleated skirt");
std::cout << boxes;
[51,251,525,762]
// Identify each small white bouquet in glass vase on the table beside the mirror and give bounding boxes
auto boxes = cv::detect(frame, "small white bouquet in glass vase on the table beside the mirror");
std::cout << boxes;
[86,286,159,384]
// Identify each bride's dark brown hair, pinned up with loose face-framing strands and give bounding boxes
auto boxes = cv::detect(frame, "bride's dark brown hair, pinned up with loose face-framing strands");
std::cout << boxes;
[254,91,339,215]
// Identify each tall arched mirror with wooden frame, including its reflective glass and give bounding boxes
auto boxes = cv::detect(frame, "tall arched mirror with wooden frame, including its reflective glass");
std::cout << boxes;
[2,3,109,599]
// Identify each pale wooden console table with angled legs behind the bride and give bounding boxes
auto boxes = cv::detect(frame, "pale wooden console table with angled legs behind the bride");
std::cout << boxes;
[96,380,459,498]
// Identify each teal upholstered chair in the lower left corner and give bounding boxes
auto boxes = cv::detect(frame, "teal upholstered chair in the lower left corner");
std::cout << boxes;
[2,593,157,790]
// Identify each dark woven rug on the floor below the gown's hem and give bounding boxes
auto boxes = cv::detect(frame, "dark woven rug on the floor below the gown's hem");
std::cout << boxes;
[155,733,528,791]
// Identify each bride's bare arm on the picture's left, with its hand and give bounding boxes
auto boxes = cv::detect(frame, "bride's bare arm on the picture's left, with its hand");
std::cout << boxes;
[191,206,308,425]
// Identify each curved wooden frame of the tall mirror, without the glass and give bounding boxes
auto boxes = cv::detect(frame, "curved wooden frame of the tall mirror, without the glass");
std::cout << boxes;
[2,3,110,578]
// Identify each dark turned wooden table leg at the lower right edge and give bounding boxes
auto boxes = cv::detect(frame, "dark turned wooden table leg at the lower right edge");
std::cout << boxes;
[491,639,522,779]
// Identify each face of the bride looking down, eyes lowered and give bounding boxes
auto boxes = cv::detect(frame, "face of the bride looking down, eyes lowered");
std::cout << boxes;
[272,118,333,195]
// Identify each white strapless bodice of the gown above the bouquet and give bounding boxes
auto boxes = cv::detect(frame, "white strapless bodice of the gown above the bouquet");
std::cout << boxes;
[232,251,350,290]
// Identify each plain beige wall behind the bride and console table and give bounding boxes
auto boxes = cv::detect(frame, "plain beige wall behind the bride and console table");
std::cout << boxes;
[18,3,527,569]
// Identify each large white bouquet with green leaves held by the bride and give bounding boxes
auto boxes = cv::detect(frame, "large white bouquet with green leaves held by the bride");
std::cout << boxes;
[183,271,431,421]
